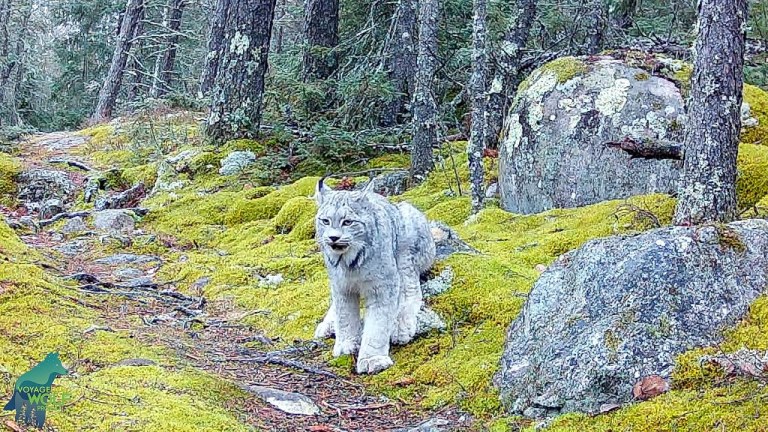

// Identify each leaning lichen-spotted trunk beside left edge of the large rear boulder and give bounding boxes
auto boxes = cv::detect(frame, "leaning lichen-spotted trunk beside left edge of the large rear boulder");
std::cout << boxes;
[485,0,537,148]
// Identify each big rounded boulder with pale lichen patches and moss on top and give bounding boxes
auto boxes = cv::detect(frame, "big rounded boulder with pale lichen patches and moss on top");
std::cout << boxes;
[499,57,686,214]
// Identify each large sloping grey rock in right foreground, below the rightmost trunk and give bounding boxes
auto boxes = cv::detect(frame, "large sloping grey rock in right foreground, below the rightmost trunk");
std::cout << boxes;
[494,219,768,416]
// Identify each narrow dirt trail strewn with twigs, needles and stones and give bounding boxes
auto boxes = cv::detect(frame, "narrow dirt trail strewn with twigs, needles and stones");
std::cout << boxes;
[0,133,471,431]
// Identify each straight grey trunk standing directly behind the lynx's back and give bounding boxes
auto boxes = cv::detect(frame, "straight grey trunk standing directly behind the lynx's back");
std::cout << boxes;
[411,0,440,183]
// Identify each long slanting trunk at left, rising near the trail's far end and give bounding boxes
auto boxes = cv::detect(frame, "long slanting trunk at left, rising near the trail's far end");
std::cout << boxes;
[91,0,144,122]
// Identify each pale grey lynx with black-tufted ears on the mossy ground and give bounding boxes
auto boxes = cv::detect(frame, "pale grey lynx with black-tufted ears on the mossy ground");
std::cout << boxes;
[315,180,435,374]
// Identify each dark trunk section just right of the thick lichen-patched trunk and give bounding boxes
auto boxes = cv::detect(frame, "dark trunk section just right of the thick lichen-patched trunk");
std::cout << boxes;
[304,0,339,81]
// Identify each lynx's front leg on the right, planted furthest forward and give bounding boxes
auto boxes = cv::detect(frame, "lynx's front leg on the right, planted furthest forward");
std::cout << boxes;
[357,282,398,374]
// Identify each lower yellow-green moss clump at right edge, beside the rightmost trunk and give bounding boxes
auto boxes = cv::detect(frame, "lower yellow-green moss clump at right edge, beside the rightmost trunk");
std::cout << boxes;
[736,144,768,210]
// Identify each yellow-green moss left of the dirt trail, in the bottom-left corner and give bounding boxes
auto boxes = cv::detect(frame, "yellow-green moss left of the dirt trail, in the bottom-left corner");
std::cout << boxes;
[0,221,249,432]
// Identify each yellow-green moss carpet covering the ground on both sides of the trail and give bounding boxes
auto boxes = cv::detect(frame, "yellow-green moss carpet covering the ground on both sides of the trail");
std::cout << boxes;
[0,113,768,430]
